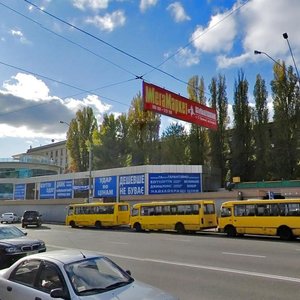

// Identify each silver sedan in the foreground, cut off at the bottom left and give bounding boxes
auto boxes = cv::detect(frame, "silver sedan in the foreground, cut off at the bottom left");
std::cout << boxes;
[0,250,178,300]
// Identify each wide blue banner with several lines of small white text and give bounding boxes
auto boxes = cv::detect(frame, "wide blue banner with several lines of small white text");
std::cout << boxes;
[149,173,201,195]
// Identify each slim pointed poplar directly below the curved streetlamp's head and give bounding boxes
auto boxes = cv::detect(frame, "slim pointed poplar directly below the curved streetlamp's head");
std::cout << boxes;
[253,74,272,180]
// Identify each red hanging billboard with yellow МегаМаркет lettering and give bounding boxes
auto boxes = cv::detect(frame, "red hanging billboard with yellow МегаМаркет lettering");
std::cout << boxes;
[143,81,218,130]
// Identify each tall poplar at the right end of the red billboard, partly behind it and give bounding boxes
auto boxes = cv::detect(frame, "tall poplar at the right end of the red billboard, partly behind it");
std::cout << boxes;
[209,75,230,185]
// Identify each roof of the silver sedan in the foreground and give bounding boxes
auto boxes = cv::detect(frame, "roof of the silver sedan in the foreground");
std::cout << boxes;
[22,249,104,264]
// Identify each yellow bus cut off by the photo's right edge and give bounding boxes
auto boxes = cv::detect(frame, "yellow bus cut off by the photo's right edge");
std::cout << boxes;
[218,199,300,240]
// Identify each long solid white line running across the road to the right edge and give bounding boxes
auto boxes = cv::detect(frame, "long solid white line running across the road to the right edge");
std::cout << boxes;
[48,245,300,283]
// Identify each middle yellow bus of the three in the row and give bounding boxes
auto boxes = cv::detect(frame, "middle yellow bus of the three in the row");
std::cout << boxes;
[130,200,217,233]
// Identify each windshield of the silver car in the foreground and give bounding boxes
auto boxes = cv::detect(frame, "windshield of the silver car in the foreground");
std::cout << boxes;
[65,257,133,295]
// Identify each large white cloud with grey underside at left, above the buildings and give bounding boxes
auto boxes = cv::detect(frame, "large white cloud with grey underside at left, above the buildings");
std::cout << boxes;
[0,73,111,139]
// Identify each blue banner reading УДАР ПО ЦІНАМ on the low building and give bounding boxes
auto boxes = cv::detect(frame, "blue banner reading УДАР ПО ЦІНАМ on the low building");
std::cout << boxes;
[94,176,117,197]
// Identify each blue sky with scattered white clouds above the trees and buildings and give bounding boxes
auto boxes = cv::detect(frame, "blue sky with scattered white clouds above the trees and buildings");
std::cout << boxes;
[0,0,300,159]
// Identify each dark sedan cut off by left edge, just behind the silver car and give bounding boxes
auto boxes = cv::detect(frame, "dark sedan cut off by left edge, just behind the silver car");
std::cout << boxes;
[0,224,46,268]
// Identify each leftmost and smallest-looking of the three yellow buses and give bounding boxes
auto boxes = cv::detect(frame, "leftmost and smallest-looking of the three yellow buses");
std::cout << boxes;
[66,202,130,228]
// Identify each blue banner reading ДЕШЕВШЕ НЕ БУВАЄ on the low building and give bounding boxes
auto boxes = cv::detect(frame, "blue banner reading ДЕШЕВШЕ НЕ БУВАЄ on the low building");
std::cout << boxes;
[119,174,145,196]
